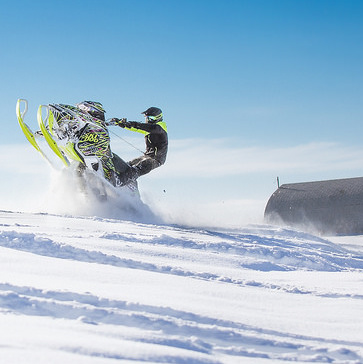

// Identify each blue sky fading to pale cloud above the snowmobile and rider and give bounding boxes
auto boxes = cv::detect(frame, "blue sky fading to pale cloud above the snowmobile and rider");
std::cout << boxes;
[0,0,363,228]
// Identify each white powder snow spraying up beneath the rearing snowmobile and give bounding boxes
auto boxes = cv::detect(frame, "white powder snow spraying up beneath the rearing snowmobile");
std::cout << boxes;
[42,168,162,223]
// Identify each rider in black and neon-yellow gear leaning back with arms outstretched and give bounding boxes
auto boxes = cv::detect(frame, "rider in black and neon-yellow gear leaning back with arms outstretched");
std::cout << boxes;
[111,106,168,184]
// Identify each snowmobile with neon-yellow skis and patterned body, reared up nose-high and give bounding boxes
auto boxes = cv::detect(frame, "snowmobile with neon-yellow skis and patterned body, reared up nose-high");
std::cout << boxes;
[16,99,138,195]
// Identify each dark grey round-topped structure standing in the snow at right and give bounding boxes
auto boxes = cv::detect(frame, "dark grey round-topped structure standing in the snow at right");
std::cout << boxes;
[265,177,363,235]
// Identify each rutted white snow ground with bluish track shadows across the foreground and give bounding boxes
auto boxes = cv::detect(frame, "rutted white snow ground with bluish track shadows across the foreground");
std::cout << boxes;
[0,211,363,364]
